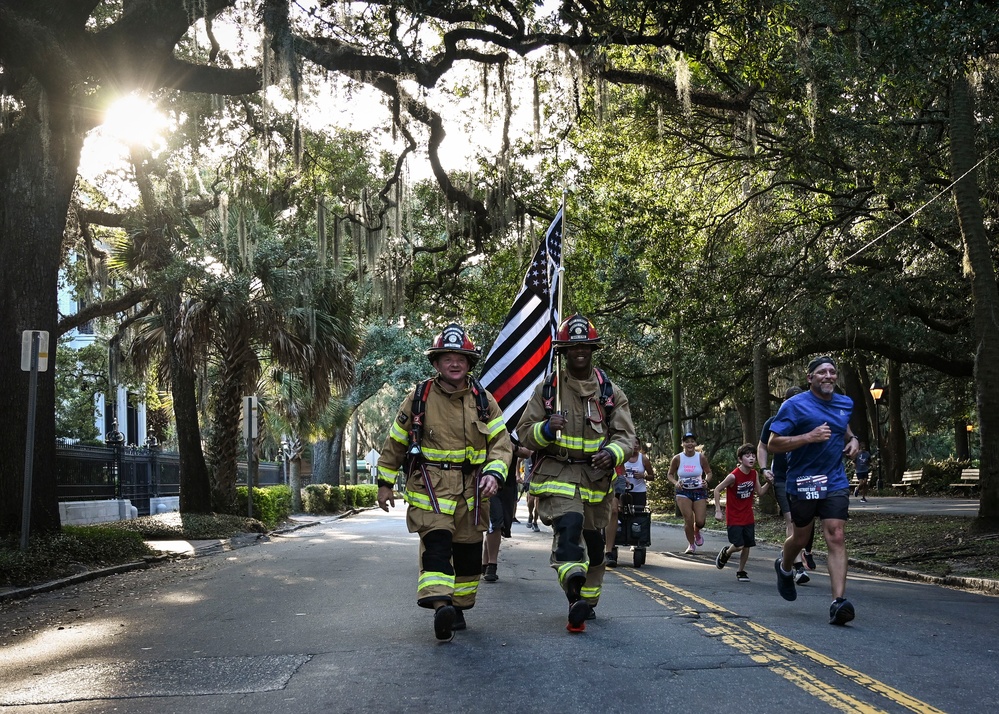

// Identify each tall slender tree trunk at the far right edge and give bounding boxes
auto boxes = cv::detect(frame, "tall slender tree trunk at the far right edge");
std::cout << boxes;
[950,67,999,519]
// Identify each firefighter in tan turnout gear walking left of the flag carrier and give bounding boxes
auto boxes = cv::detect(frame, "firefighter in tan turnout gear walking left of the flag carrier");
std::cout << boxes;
[377,324,513,640]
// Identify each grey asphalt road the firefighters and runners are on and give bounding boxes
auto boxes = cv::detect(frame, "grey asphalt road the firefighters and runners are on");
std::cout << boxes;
[0,500,999,714]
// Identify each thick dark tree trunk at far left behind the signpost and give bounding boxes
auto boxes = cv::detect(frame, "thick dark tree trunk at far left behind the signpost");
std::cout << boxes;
[0,86,89,536]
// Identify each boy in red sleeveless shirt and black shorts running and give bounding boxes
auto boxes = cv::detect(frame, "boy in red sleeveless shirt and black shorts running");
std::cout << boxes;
[714,444,774,583]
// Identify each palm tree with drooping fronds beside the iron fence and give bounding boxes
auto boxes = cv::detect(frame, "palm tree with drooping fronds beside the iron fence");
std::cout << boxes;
[199,206,357,512]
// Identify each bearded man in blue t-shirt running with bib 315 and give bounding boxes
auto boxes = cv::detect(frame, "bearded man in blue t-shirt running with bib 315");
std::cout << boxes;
[767,355,859,625]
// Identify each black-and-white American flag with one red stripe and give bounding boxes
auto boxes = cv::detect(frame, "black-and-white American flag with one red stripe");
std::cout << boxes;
[480,206,564,429]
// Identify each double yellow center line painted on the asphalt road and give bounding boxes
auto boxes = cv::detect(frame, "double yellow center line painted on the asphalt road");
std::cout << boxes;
[614,569,945,714]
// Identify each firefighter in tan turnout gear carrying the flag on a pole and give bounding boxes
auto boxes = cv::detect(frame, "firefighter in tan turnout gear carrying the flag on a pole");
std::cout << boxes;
[517,313,635,632]
